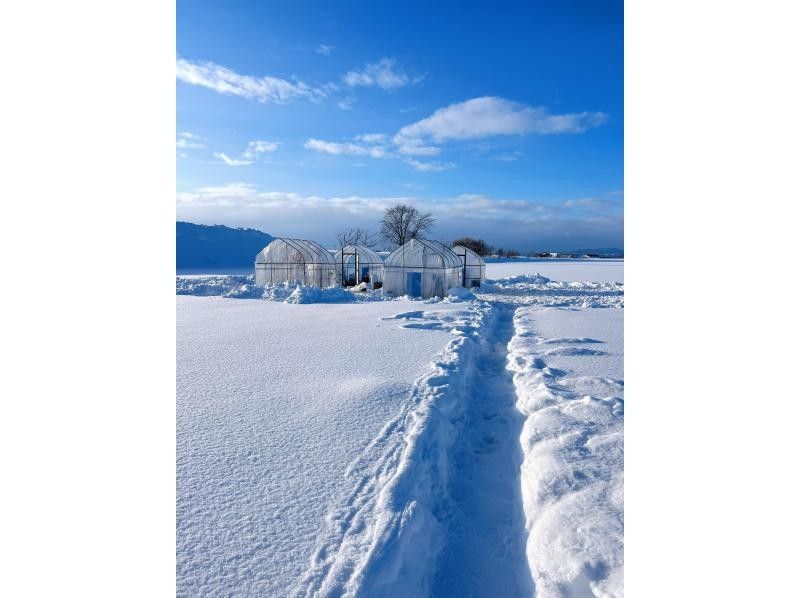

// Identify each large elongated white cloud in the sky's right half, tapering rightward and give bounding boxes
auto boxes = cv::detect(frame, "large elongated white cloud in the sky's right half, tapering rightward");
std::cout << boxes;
[394,96,608,148]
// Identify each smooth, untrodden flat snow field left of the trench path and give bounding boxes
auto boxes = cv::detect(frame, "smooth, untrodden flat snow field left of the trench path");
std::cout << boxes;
[177,297,476,595]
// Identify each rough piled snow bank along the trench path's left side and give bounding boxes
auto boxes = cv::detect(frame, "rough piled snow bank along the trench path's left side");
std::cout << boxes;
[293,304,488,596]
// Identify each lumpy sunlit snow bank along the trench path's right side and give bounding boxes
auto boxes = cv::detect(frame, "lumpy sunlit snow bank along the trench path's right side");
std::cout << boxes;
[508,307,624,597]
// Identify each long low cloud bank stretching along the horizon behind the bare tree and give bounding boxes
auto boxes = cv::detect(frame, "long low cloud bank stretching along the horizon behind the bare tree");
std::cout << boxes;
[177,183,623,251]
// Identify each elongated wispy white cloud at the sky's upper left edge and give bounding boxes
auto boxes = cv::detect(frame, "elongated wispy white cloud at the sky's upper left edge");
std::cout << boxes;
[176,58,326,104]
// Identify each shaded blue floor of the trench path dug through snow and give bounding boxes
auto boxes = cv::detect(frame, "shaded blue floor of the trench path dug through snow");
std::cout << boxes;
[432,305,533,597]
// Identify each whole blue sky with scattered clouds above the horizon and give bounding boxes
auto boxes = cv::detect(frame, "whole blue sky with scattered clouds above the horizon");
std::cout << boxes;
[176,0,624,251]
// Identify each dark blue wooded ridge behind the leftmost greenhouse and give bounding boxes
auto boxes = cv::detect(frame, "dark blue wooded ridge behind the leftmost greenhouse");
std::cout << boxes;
[175,222,273,270]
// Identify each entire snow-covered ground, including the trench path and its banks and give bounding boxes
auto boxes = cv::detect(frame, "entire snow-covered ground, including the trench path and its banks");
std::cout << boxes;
[176,261,624,597]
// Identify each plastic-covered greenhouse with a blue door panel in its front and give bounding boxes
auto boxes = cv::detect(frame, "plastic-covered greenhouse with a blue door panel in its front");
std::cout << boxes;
[383,239,462,297]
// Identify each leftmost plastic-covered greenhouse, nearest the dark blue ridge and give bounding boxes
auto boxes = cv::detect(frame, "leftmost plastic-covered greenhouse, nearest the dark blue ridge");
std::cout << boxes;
[256,238,336,287]
